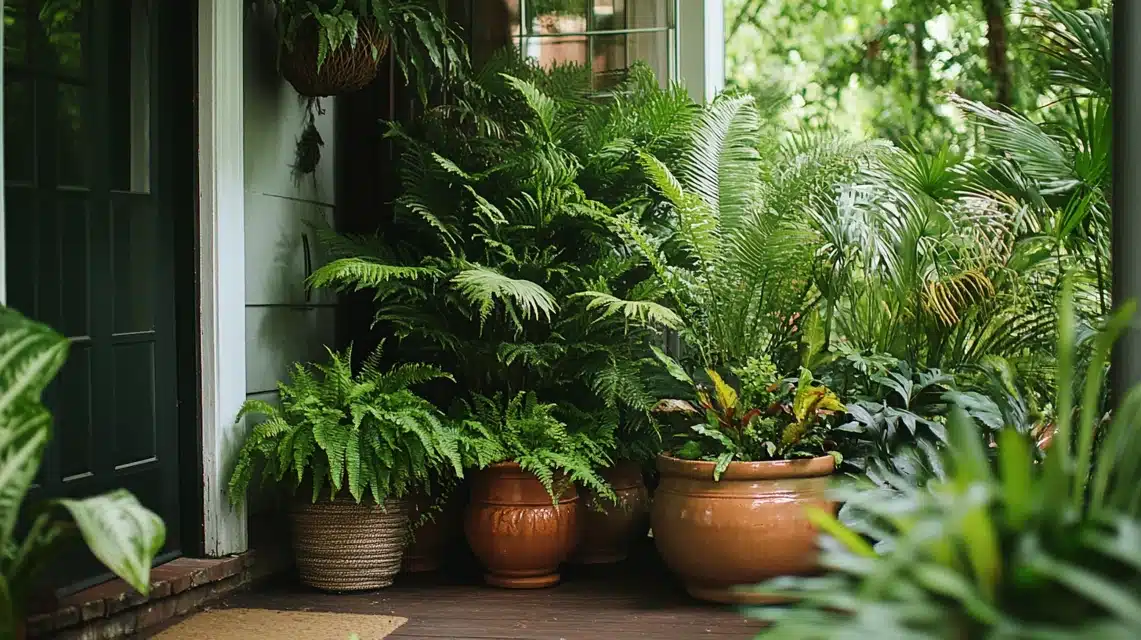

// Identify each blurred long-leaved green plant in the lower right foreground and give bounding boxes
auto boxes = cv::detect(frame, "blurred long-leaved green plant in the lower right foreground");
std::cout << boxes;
[753,283,1141,639]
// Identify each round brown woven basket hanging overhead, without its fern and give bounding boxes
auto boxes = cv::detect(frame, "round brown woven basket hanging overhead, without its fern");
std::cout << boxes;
[281,18,388,98]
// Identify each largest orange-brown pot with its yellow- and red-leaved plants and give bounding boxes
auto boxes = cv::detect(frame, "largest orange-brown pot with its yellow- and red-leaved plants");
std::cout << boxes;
[650,353,844,603]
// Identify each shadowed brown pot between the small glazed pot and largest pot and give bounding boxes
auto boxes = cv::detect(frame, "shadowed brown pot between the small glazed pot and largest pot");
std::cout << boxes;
[571,462,649,565]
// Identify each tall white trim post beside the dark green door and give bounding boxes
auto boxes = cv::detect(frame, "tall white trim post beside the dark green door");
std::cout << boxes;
[199,0,249,557]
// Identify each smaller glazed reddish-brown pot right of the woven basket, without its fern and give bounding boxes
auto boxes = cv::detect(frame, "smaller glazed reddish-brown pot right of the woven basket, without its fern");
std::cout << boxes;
[463,462,578,589]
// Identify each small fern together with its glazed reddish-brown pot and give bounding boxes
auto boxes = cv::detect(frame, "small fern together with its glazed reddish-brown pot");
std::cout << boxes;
[463,392,615,589]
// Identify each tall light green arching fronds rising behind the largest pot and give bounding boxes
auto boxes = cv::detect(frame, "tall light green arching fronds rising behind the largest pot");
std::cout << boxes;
[579,88,876,368]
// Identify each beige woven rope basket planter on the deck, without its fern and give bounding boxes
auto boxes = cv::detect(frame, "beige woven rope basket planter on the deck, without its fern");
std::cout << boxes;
[290,490,408,591]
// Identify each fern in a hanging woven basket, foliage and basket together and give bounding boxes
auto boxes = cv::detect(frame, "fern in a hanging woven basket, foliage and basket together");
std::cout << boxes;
[270,0,463,97]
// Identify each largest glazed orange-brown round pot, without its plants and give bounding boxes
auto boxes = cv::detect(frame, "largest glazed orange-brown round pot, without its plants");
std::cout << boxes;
[652,455,836,605]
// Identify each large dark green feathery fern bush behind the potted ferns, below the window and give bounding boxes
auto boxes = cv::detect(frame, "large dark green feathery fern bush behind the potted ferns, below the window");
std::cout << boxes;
[310,55,695,457]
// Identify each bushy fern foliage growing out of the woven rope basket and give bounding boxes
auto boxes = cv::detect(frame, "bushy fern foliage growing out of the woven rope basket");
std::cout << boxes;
[229,348,464,504]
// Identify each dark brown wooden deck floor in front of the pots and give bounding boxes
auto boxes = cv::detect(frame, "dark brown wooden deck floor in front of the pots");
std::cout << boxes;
[193,543,760,640]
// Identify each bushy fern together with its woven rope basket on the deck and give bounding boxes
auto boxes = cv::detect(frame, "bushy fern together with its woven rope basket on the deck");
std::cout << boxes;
[229,348,462,591]
